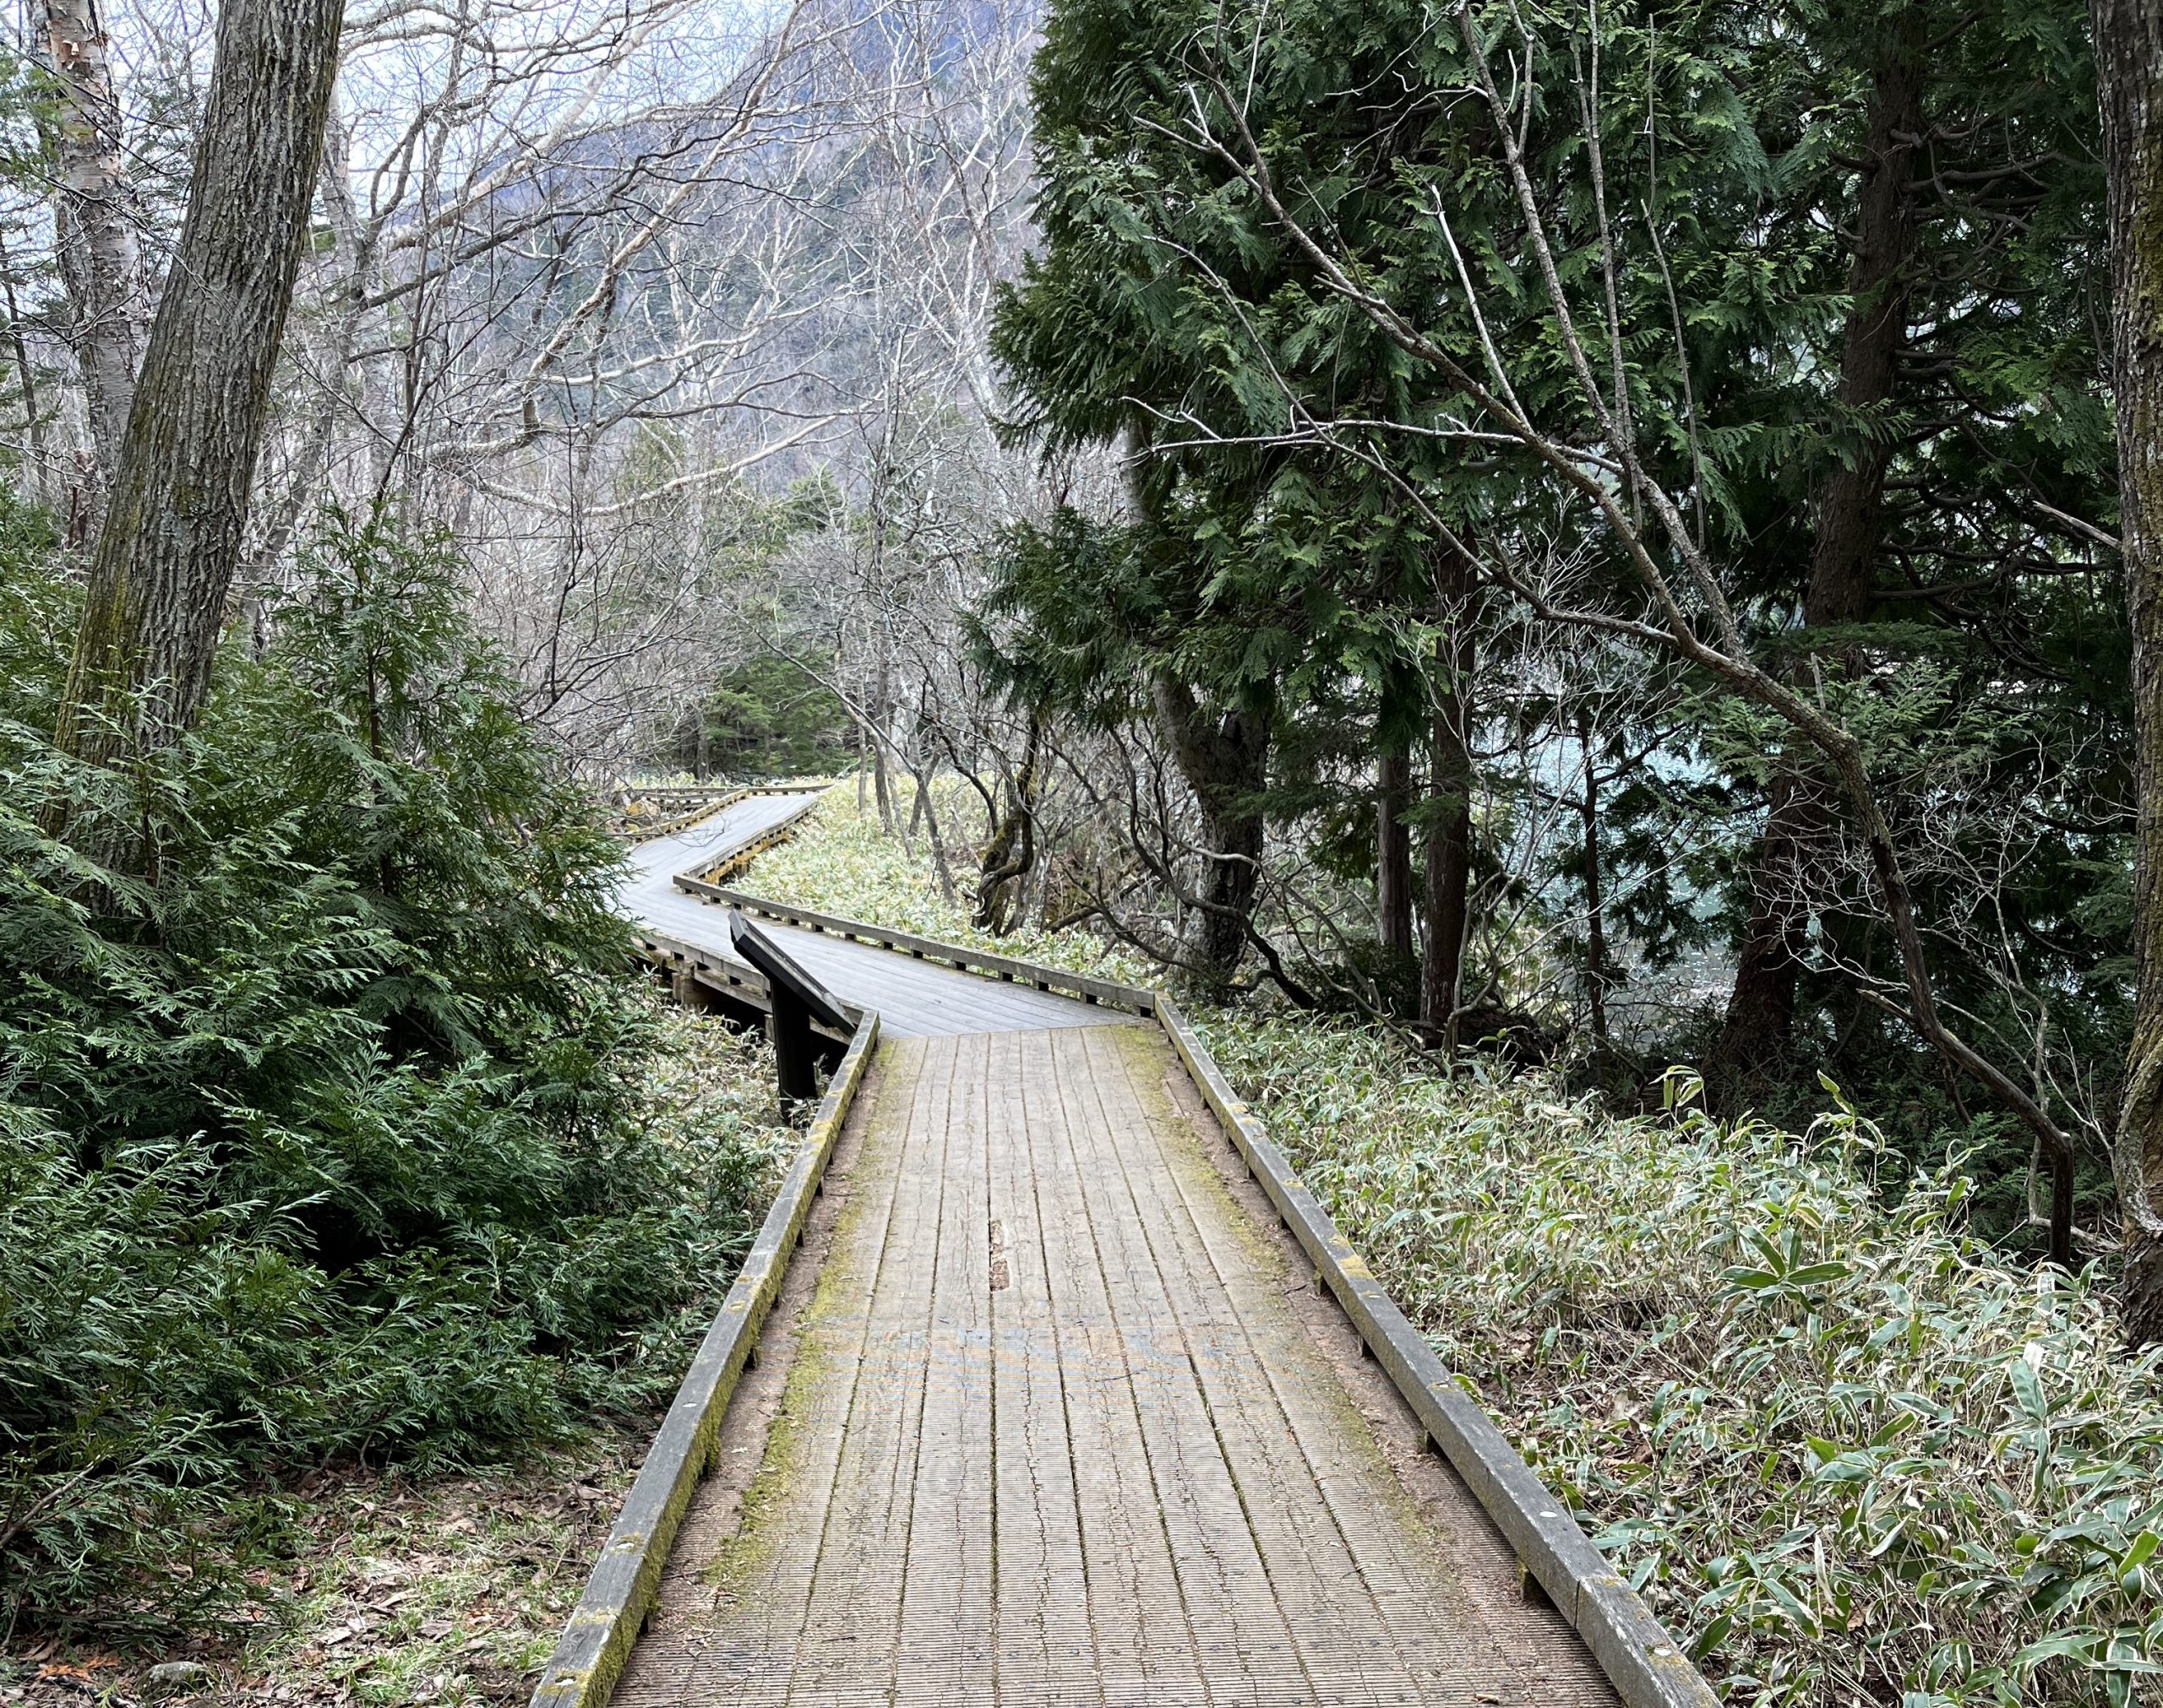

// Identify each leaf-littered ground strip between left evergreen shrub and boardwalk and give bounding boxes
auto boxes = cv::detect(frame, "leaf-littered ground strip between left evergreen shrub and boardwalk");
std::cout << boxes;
[0,990,792,1708]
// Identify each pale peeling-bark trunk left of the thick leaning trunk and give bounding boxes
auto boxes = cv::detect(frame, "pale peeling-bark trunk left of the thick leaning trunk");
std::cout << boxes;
[46,0,144,514]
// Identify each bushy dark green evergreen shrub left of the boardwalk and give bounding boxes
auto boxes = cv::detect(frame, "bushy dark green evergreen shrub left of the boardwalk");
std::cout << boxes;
[0,514,778,1624]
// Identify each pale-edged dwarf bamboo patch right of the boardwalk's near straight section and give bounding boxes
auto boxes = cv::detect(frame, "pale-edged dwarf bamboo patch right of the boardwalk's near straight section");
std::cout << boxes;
[1201,1012,2163,1708]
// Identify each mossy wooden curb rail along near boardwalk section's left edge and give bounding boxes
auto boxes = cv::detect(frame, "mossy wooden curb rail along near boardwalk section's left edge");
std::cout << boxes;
[532,1014,878,1708]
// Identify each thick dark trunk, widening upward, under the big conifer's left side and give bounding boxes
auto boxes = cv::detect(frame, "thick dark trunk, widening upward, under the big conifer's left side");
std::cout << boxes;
[1151,675,1270,984]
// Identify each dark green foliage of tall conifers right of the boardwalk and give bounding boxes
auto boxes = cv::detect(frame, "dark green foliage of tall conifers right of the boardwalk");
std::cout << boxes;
[995,0,2131,1232]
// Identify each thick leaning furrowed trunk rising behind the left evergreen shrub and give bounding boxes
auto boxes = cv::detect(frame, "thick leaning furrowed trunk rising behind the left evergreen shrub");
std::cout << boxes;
[61,0,344,759]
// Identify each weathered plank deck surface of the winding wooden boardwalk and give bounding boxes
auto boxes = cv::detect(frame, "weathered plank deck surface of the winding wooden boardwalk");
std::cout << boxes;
[552,802,1643,1708]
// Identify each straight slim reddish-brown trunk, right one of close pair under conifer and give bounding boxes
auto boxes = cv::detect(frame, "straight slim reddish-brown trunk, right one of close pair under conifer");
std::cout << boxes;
[1419,553,1475,1048]
